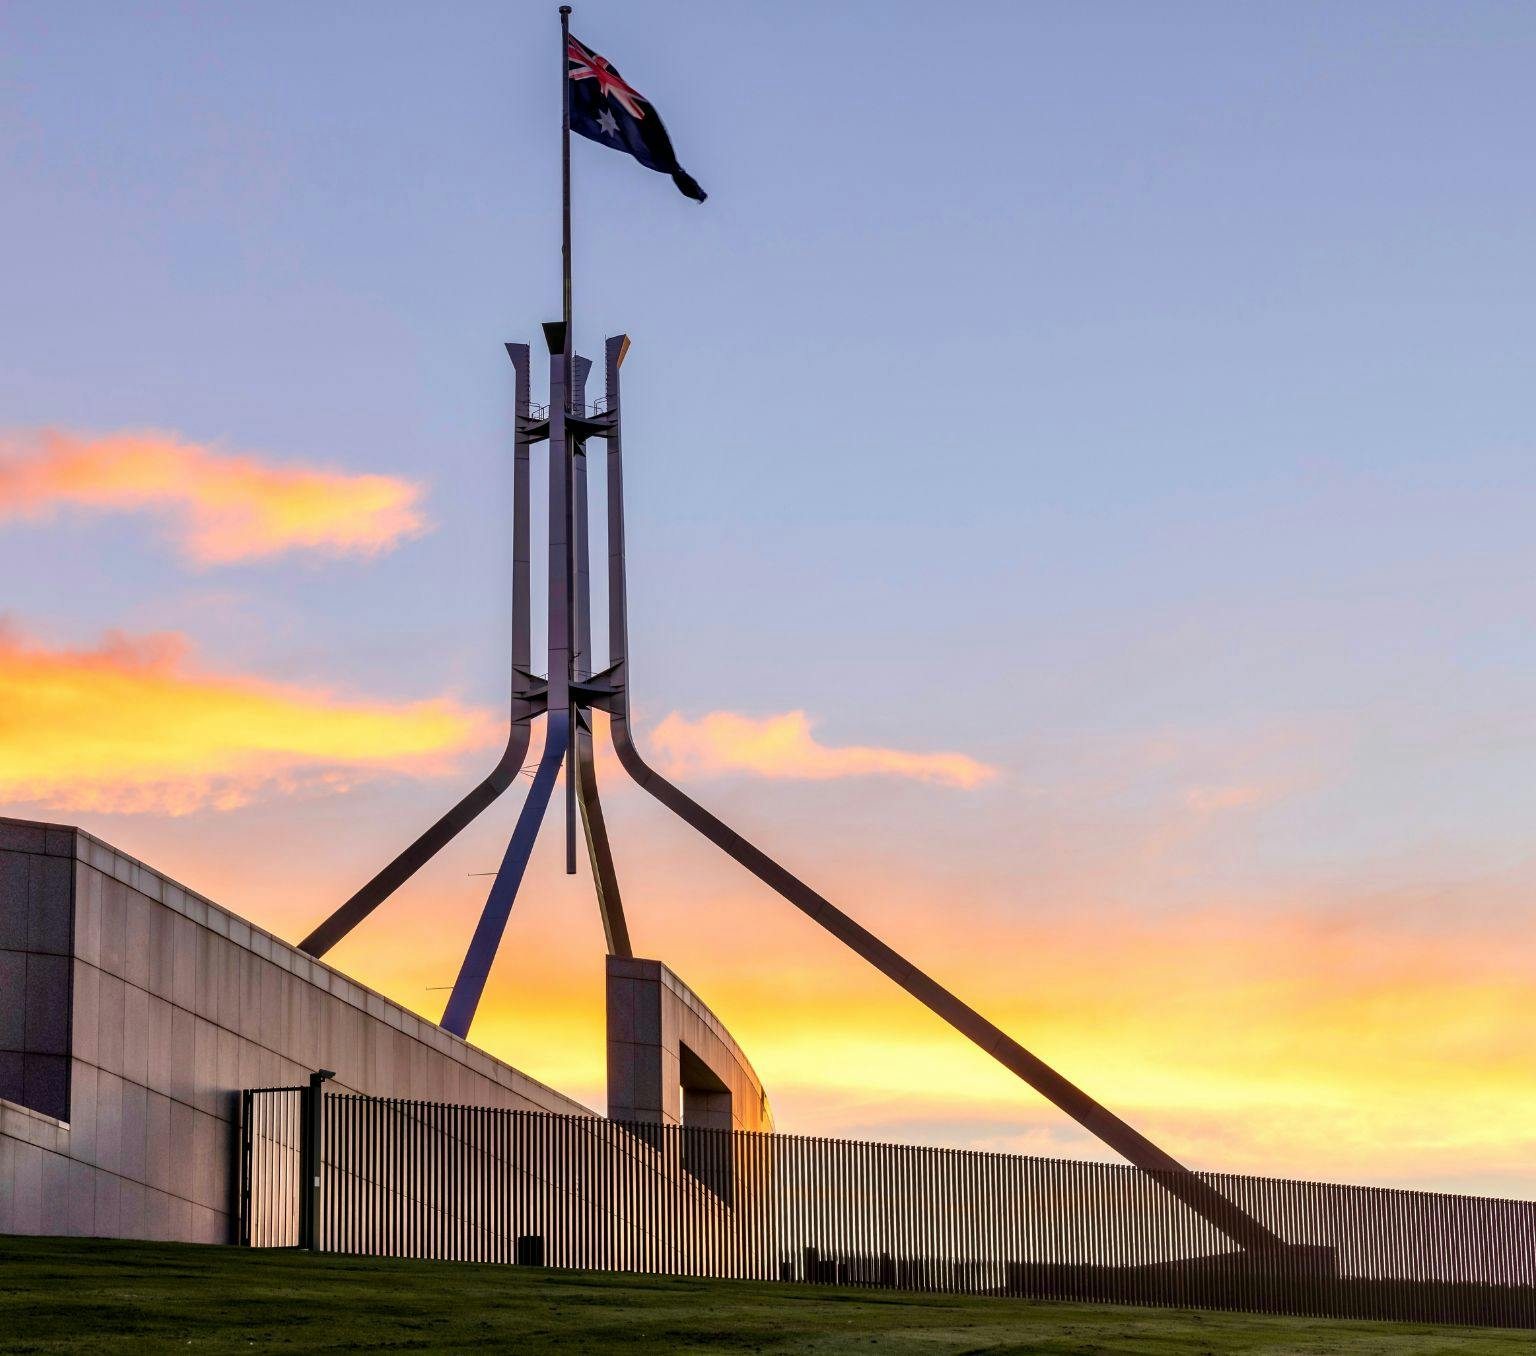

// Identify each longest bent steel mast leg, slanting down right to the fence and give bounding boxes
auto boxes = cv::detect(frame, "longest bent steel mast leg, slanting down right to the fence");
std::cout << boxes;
[595,336,1284,1250]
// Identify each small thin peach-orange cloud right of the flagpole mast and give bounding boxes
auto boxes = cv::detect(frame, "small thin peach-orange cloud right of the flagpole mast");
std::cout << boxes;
[651,711,997,789]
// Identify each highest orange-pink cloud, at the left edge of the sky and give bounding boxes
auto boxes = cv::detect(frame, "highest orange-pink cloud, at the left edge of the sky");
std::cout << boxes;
[0,428,425,565]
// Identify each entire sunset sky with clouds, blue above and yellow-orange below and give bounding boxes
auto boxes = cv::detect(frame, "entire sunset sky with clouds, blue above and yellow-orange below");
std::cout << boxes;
[0,0,1536,1198]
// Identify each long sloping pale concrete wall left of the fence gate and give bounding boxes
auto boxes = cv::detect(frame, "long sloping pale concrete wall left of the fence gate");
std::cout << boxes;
[0,819,591,1242]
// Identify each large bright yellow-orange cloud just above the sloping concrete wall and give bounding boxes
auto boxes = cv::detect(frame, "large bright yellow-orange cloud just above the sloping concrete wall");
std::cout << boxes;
[0,627,492,814]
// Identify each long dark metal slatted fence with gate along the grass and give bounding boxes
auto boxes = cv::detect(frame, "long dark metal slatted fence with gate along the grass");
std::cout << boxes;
[243,1089,1536,1327]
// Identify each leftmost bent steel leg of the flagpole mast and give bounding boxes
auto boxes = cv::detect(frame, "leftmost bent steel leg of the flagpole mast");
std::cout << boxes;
[298,344,544,958]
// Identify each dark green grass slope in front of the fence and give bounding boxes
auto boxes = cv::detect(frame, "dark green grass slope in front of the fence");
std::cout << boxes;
[0,1236,1536,1356]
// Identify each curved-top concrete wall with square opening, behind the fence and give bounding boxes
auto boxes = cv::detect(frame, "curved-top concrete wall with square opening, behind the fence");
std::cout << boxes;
[608,957,773,1130]
